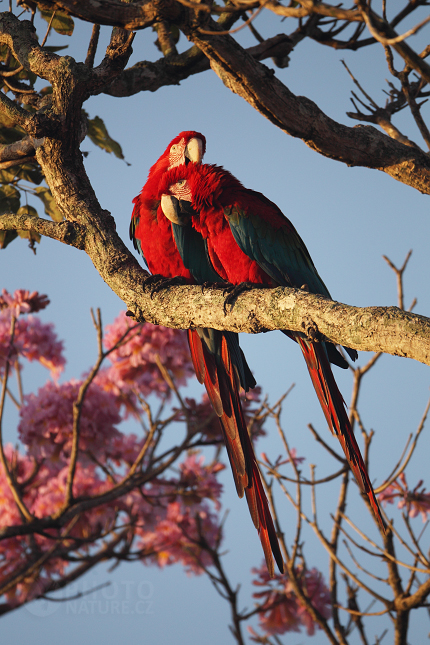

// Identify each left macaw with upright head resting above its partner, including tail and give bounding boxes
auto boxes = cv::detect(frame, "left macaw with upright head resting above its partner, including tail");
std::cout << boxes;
[130,132,284,576]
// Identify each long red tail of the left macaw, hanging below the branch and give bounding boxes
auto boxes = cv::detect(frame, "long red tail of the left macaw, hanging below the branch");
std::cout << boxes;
[188,329,284,577]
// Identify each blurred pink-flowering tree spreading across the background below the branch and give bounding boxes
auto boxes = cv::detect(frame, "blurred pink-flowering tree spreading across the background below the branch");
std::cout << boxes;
[0,264,430,645]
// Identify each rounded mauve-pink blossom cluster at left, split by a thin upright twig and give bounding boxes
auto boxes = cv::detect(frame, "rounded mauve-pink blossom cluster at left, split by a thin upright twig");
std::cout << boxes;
[18,380,122,470]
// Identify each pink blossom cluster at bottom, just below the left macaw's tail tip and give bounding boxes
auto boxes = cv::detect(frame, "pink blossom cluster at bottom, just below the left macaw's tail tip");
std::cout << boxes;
[252,564,331,642]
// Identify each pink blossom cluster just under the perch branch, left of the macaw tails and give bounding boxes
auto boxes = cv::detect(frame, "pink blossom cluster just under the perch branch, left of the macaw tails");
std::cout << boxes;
[101,311,194,396]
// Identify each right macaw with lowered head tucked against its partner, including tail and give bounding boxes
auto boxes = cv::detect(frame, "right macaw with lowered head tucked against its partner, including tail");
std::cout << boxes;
[159,164,386,530]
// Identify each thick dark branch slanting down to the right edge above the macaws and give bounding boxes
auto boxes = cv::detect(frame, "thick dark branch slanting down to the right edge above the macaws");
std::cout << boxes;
[181,23,430,194]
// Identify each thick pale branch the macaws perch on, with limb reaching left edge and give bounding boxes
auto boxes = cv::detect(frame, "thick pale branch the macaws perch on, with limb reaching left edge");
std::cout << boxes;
[0,205,430,365]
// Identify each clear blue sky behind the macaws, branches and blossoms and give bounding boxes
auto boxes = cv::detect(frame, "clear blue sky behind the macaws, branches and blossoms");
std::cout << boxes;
[0,6,430,645]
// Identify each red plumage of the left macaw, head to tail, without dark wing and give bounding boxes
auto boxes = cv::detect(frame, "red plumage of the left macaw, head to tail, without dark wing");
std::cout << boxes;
[130,132,283,576]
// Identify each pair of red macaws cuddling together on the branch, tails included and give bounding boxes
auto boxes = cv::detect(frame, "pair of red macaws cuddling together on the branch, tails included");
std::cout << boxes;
[130,131,385,576]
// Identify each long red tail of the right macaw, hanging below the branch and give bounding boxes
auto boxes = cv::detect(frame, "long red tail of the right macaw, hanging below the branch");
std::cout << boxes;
[295,336,387,531]
